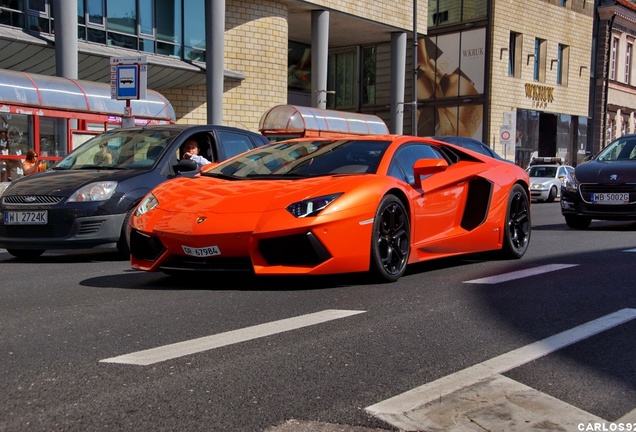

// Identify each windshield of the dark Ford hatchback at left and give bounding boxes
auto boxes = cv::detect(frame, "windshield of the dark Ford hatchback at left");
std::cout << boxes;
[53,128,180,170]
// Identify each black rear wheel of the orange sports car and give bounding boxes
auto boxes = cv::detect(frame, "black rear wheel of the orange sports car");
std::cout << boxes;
[501,184,532,259]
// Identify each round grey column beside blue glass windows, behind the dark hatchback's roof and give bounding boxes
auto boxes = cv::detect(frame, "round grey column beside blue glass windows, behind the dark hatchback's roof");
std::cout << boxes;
[205,0,225,125]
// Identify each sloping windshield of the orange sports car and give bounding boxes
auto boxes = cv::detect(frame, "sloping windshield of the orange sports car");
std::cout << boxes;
[204,139,390,178]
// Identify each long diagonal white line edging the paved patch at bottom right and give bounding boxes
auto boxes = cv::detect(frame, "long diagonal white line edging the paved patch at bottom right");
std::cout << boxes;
[366,309,636,430]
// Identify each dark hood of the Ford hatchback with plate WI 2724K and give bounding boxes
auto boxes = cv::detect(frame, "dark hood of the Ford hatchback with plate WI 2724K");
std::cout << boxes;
[4,170,147,197]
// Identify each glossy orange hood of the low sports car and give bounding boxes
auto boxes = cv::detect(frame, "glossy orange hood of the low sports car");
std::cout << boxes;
[153,175,384,215]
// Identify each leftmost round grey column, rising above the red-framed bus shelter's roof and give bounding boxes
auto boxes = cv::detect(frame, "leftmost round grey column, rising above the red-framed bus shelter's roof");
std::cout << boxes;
[51,0,78,79]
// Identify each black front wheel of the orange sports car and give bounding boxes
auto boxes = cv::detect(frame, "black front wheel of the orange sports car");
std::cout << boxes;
[371,194,411,282]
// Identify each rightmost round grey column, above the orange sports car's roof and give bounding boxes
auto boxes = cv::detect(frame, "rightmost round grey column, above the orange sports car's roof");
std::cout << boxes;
[391,32,406,135]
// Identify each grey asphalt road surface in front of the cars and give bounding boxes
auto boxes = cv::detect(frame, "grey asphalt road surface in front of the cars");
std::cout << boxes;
[0,202,636,432]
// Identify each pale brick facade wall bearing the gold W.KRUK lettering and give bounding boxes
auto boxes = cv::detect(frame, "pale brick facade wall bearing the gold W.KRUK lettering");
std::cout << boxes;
[488,0,594,153]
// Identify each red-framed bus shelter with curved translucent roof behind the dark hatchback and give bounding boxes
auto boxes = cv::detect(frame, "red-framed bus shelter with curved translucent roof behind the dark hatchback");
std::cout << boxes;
[0,69,175,181]
